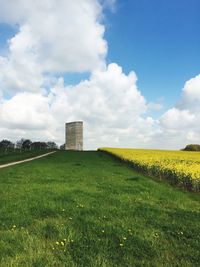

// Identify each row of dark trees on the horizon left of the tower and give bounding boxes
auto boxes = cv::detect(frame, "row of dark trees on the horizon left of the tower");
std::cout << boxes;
[0,138,58,151]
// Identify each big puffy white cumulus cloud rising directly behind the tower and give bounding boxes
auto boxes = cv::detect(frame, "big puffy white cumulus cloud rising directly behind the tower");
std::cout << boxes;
[51,64,153,148]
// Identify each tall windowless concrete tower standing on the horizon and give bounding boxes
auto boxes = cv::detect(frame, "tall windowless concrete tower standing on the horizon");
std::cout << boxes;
[65,121,83,150]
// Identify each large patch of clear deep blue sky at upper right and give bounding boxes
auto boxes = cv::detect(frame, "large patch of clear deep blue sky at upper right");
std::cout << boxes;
[106,0,200,107]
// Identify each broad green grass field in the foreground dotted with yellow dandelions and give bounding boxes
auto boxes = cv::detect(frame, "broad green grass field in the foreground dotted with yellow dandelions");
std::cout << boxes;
[0,151,200,267]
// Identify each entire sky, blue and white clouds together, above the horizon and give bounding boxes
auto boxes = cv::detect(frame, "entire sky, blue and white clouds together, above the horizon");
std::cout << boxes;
[0,0,200,149]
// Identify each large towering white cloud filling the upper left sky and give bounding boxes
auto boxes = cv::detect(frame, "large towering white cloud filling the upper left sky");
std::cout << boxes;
[0,0,107,92]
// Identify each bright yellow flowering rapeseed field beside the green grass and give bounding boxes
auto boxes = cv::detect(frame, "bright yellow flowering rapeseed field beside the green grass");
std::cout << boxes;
[99,147,200,191]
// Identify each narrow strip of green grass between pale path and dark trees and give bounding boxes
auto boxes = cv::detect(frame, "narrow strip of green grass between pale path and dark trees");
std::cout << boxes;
[0,150,54,165]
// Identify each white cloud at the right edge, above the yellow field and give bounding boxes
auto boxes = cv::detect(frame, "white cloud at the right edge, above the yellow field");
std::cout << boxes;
[158,75,200,148]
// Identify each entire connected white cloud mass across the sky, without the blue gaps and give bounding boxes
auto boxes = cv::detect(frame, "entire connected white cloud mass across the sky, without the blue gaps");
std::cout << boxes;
[0,0,200,149]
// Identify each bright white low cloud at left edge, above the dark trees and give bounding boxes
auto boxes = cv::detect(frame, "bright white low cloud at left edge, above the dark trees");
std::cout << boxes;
[0,92,53,130]
